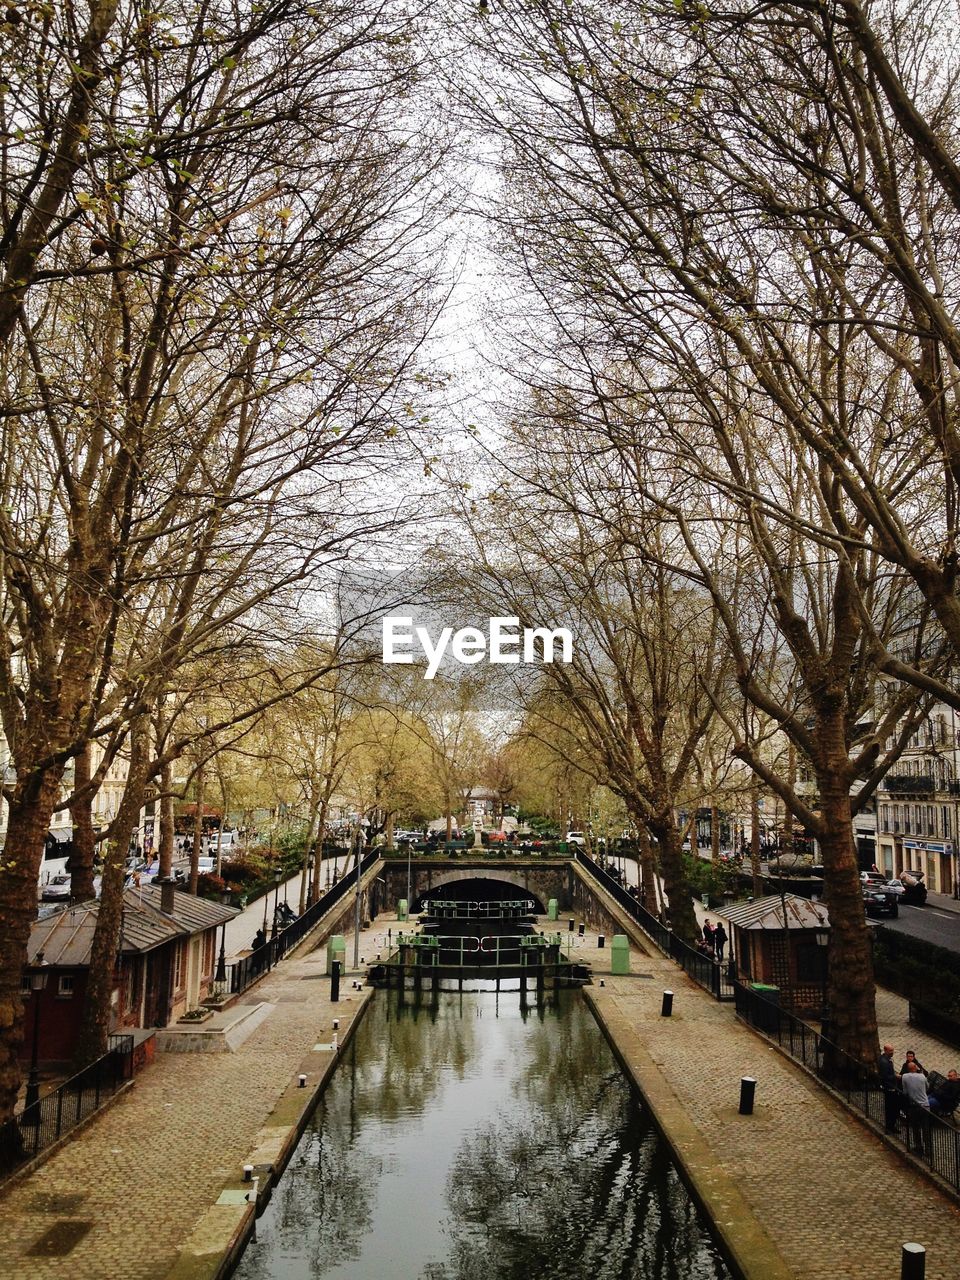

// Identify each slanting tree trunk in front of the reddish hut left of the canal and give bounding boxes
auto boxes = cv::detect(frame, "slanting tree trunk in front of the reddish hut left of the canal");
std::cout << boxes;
[76,716,150,1068]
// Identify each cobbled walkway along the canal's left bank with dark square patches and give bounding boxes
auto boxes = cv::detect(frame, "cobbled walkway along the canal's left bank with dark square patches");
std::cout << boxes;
[0,908,389,1280]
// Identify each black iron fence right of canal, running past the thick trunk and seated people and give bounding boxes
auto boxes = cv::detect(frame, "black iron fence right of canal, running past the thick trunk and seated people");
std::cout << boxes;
[733,982,960,1192]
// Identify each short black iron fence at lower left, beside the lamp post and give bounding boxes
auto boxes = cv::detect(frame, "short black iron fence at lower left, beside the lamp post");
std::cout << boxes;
[0,1036,133,1179]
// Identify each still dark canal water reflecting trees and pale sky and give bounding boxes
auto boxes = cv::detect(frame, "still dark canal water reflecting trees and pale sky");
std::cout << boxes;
[236,991,731,1280]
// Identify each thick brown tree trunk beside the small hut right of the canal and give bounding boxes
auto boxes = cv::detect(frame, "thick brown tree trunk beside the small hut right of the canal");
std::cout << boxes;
[817,747,879,1066]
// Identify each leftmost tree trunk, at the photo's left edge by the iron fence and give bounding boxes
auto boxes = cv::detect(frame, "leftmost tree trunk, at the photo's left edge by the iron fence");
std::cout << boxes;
[0,769,61,1125]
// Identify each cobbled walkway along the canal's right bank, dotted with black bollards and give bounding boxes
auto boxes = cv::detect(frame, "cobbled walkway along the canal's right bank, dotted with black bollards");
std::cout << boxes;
[577,913,960,1280]
